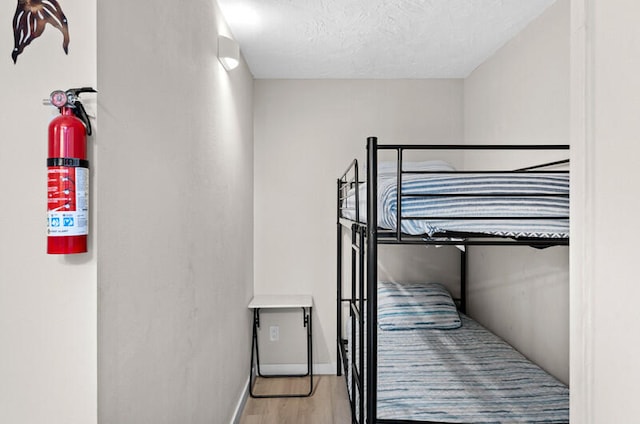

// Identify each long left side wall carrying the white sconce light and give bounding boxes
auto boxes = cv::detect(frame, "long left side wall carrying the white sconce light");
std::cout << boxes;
[98,0,253,424]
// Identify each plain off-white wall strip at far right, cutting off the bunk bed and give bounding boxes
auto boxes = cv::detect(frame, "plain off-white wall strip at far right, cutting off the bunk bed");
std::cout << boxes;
[571,0,640,423]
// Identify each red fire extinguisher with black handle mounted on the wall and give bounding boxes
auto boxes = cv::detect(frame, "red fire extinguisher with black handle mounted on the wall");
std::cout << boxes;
[47,87,96,254]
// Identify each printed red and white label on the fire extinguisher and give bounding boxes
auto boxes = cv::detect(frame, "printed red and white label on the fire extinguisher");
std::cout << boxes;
[47,166,89,237]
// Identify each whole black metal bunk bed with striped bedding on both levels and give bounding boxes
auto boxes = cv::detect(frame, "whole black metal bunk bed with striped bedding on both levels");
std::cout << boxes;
[336,137,569,424]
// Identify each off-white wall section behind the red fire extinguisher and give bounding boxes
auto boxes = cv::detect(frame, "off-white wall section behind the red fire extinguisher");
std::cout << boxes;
[0,0,99,424]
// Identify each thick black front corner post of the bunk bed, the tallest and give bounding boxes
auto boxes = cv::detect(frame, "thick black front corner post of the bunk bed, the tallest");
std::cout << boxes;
[365,137,378,424]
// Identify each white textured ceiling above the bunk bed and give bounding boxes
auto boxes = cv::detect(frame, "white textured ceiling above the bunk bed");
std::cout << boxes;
[218,0,555,79]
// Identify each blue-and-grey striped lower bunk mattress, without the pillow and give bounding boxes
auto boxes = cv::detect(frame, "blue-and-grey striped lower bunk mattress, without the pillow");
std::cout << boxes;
[377,314,569,423]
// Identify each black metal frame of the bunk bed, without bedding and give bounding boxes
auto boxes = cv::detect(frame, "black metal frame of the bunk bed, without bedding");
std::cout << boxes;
[336,137,569,424]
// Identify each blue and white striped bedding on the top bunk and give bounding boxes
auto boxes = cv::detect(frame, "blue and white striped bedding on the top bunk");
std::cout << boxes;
[343,173,569,238]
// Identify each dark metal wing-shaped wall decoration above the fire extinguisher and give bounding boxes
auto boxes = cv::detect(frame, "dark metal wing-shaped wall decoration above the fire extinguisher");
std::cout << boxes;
[11,0,69,63]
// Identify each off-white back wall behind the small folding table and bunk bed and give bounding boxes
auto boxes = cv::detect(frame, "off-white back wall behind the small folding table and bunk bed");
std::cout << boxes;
[254,80,463,372]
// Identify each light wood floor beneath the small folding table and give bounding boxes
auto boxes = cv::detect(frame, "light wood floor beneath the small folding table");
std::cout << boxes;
[240,375,351,424]
